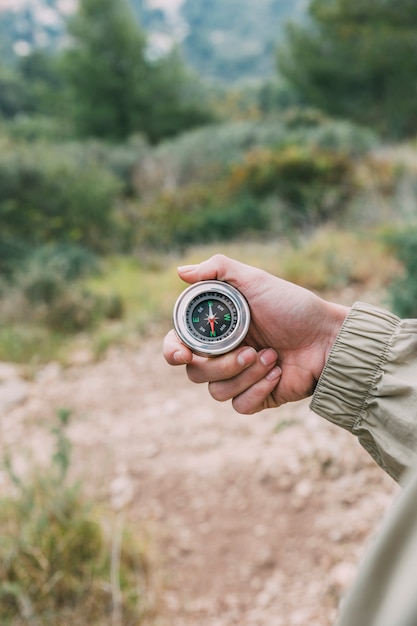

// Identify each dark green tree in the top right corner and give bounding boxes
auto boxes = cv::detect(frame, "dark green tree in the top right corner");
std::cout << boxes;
[278,0,417,138]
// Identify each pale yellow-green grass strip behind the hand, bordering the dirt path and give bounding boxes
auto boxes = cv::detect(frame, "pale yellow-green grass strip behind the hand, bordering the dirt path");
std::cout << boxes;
[0,228,398,365]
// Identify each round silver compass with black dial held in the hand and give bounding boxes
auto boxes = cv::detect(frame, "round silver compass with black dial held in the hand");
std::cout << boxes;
[174,280,250,356]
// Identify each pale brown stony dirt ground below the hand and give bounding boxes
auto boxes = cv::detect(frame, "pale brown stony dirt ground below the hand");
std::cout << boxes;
[0,340,397,626]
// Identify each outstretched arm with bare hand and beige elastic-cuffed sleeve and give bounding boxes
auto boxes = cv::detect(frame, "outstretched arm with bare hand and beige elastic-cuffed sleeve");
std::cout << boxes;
[164,256,417,480]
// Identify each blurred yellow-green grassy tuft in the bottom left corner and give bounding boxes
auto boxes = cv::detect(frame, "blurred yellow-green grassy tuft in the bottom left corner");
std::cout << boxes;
[0,409,148,626]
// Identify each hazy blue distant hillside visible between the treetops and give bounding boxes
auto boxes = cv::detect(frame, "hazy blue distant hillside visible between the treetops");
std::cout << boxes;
[0,0,307,82]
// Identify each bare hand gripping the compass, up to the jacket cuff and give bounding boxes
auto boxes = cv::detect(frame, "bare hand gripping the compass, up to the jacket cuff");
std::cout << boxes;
[163,255,349,414]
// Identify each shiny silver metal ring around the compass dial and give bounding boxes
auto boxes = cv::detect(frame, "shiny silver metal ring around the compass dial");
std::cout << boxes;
[173,280,250,357]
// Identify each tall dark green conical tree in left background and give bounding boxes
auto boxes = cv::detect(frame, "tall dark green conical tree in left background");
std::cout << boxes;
[63,0,149,139]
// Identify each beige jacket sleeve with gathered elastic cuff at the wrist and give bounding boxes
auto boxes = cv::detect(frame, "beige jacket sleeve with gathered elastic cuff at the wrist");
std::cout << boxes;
[311,302,417,481]
